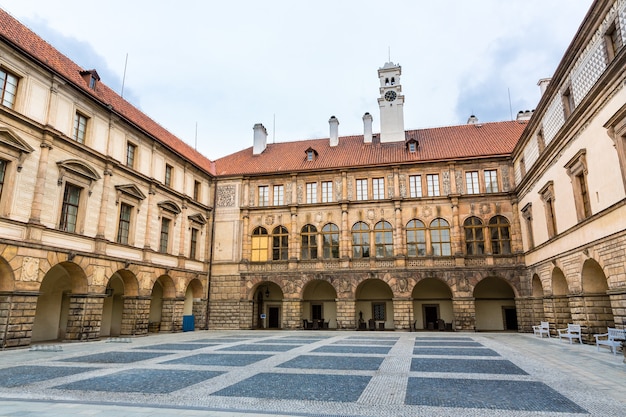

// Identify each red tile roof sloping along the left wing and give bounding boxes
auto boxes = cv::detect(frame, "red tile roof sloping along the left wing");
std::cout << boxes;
[0,9,214,174]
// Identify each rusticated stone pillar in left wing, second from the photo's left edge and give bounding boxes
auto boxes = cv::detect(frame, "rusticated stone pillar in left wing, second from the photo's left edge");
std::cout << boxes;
[65,294,104,341]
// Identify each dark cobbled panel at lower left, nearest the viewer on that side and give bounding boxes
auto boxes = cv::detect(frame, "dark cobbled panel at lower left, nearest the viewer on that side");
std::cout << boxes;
[54,369,222,394]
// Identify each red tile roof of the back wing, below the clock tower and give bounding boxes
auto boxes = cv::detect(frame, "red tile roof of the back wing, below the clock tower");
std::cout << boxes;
[215,121,526,176]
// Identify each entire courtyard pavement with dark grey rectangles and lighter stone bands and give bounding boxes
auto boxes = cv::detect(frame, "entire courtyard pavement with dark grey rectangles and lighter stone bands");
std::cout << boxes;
[0,331,626,417]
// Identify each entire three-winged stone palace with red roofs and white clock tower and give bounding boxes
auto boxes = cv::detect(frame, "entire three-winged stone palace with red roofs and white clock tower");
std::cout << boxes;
[0,0,626,347]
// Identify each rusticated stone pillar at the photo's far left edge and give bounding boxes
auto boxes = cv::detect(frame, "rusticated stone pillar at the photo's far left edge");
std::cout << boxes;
[0,292,38,349]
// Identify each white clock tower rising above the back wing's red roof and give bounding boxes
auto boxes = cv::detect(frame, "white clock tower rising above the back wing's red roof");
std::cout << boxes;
[378,62,405,143]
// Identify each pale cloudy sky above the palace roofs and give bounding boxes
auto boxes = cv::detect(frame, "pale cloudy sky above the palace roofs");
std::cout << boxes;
[0,0,592,160]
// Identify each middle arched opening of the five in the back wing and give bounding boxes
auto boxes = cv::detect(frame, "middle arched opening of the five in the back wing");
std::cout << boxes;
[355,278,394,329]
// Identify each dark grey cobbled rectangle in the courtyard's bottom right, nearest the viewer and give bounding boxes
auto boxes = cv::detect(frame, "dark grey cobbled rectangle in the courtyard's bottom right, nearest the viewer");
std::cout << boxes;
[405,378,587,414]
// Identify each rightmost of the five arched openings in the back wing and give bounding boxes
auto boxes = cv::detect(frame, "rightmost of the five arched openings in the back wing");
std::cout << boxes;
[474,276,518,331]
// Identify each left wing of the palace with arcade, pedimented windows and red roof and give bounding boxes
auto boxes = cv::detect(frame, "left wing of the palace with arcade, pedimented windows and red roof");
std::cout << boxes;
[0,10,214,347]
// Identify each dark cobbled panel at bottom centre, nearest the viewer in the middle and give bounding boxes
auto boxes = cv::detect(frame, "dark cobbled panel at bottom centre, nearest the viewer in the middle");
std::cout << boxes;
[213,373,371,402]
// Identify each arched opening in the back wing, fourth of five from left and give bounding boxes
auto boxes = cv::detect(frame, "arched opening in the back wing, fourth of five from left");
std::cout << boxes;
[411,278,454,330]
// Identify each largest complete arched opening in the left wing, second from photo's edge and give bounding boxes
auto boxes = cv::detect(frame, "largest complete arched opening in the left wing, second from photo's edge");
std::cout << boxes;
[31,262,88,342]
